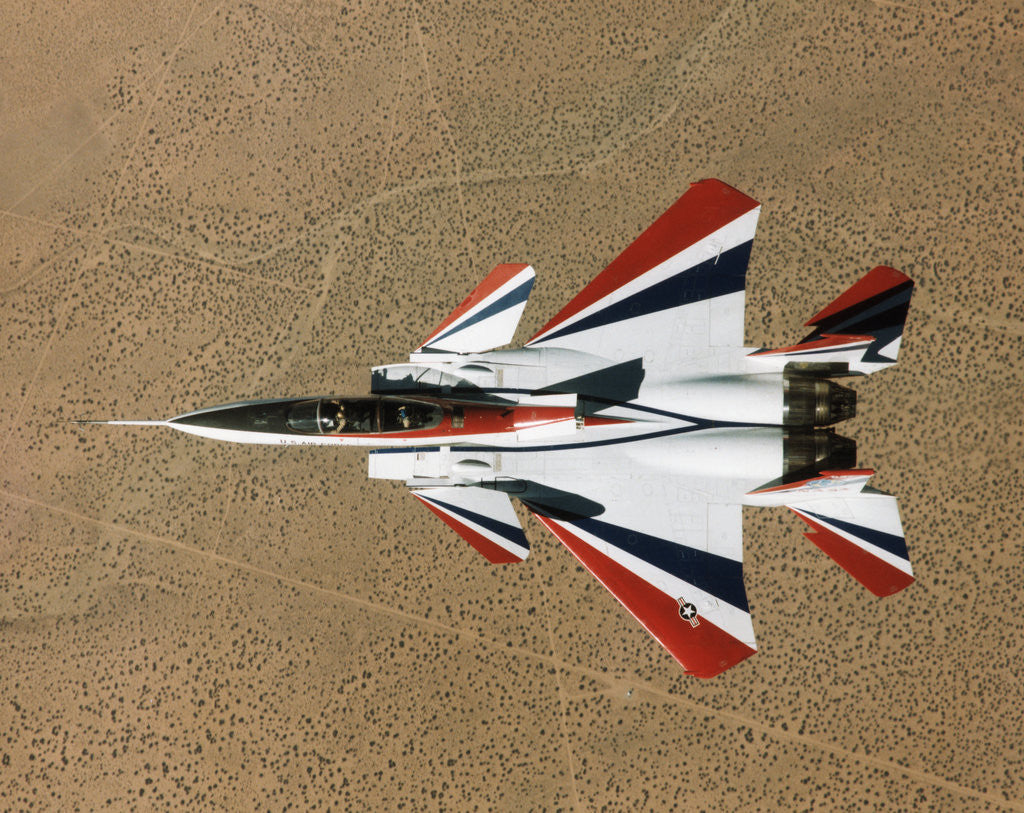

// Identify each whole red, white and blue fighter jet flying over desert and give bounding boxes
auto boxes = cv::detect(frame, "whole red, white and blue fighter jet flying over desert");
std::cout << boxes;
[92,180,913,678]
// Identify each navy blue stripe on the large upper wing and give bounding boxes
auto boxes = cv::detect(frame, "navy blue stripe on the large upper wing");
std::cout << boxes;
[538,240,754,342]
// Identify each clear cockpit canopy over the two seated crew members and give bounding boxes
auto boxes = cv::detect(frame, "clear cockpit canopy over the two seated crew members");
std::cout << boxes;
[288,398,444,435]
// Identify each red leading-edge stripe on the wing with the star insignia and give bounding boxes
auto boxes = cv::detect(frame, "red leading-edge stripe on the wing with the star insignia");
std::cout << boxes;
[534,514,756,678]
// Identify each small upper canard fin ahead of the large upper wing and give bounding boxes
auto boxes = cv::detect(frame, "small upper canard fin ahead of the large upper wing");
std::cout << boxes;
[415,263,535,353]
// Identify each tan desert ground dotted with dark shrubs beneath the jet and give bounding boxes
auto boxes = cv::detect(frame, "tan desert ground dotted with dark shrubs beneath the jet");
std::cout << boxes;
[0,0,1024,811]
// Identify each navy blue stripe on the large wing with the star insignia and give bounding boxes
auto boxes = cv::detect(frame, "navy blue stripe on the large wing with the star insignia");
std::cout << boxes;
[572,519,750,612]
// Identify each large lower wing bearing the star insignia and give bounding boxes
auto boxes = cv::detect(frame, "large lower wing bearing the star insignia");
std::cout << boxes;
[517,448,757,678]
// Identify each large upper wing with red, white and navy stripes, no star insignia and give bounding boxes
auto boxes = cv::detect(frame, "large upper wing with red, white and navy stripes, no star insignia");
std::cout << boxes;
[528,180,761,369]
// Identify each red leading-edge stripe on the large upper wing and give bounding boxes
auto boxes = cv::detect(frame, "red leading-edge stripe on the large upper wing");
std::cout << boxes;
[530,178,760,341]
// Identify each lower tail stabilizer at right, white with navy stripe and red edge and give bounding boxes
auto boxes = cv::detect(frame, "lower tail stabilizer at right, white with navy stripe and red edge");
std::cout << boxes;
[786,488,913,596]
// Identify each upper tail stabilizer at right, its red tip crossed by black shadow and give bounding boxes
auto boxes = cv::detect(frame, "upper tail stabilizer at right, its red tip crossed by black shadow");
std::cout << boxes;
[751,265,913,376]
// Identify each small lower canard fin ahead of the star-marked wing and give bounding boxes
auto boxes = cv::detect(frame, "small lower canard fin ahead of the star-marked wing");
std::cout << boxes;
[413,486,529,564]
